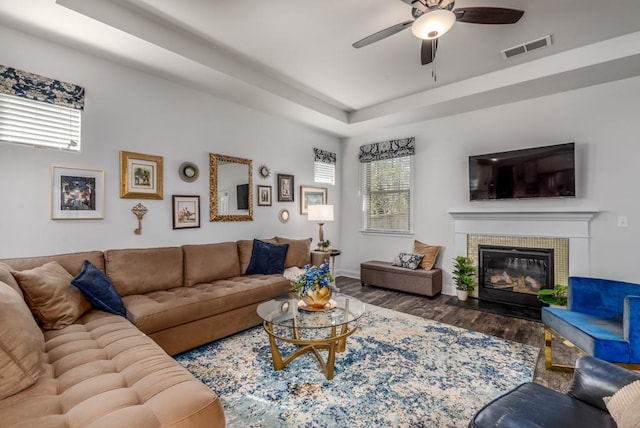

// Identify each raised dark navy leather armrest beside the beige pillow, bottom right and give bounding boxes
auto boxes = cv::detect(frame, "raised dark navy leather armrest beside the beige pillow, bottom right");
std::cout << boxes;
[568,355,640,411]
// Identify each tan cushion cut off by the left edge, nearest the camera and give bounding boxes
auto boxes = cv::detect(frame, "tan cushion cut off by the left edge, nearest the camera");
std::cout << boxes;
[0,282,44,400]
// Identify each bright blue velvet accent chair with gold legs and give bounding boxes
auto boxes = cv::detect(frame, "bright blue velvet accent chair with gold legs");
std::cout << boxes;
[542,276,640,370]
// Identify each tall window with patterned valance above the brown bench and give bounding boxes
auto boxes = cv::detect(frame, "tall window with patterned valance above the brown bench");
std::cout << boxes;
[360,138,414,233]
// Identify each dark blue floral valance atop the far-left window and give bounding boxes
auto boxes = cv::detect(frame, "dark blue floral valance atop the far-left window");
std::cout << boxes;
[0,65,84,110]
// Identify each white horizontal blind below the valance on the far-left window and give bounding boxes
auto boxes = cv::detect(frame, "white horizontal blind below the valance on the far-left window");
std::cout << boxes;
[0,94,82,151]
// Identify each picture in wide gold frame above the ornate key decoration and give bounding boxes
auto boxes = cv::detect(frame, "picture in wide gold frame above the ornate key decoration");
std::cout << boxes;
[120,151,162,199]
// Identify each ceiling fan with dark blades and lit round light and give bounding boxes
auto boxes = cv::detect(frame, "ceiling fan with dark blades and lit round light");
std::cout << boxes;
[353,0,524,65]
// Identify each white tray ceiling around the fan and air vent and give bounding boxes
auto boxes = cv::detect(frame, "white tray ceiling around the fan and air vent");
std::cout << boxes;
[0,0,640,136]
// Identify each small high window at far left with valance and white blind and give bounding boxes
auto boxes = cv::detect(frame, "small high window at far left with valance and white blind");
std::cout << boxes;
[0,65,84,151]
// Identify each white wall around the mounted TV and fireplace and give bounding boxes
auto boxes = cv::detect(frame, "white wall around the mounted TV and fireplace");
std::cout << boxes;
[342,78,640,284]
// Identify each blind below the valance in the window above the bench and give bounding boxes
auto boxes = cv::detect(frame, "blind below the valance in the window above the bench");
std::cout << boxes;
[360,156,413,233]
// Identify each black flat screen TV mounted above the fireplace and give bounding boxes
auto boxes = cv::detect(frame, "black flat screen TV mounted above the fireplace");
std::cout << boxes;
[469,143,576,201]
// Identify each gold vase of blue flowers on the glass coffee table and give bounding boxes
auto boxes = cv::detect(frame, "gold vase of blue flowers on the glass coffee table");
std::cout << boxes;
[292,261,338,310]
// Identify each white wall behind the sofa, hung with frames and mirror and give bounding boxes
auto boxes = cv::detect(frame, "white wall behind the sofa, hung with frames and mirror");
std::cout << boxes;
[0,26,341,258]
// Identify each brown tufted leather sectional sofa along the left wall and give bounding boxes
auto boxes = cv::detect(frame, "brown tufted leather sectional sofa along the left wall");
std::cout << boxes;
[0,238,310,427]
